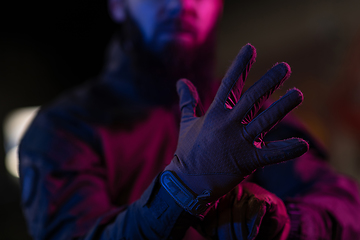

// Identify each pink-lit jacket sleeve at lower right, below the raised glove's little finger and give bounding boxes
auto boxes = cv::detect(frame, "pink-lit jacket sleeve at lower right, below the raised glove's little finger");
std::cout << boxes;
[255,150,360,240]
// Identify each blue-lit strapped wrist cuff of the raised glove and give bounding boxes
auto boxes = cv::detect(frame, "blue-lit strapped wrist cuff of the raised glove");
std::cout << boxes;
[160,171,211,218]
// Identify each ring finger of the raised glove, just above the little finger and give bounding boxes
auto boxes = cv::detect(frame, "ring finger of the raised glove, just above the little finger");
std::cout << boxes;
[245,88,303,143]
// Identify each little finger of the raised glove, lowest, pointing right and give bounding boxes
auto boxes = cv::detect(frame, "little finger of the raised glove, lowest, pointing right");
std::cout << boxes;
[257,138,309,166]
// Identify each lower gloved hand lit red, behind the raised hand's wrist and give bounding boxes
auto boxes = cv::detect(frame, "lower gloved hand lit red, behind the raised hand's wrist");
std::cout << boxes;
[196,182,290,240]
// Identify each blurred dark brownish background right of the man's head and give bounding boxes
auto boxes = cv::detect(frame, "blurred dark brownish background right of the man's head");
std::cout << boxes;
[217,0,360,180]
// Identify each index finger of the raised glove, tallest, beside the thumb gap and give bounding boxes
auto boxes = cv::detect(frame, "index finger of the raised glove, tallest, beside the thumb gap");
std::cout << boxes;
[215,44,256,109]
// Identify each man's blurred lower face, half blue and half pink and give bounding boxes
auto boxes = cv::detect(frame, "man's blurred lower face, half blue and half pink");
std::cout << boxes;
[126,0,223,53]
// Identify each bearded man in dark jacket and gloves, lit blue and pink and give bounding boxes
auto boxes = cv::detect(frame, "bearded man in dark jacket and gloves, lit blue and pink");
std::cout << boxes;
[19,0,360,239]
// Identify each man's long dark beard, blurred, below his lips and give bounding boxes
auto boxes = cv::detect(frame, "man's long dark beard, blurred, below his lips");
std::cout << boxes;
[120,14,215,105]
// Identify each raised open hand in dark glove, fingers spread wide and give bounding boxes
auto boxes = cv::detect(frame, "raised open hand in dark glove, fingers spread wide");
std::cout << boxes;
[161,44,308,216]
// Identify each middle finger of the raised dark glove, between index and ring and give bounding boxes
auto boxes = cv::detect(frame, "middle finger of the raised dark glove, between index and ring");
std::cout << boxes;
[234,63,291,124]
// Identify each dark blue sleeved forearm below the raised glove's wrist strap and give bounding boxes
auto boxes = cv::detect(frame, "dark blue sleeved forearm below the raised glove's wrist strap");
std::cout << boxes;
[86,174,194,240]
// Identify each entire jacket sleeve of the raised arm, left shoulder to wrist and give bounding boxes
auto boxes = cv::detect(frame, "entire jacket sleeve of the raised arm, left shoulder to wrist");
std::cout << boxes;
[19,109,192,240]
